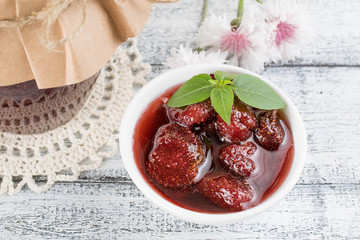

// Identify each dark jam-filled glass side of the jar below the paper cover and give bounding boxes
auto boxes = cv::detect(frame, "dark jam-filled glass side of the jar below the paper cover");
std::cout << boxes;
[0,72,100,134]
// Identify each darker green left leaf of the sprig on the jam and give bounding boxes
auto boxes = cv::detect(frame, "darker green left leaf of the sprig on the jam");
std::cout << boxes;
[167,74,215,107]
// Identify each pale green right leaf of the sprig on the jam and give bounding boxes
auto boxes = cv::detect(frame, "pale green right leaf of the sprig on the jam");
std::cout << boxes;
[232,74,286,110]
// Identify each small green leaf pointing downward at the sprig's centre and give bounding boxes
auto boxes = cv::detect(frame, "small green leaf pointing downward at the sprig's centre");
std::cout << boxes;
[210,85,234,124]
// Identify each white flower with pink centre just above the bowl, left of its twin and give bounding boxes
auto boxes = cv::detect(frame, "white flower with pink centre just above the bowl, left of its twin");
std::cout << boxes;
[195,8,268,72]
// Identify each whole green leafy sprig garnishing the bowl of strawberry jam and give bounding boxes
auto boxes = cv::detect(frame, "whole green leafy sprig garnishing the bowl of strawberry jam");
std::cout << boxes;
[167,71,286,124]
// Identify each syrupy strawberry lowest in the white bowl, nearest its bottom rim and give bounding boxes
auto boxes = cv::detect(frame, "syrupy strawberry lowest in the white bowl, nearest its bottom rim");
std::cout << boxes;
[197,174,254,211]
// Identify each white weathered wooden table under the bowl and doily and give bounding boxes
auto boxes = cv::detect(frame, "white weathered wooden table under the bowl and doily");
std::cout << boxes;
[0,0,360,239]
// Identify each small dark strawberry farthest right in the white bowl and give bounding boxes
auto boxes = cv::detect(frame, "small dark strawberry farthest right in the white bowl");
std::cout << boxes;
[255,110,285,151]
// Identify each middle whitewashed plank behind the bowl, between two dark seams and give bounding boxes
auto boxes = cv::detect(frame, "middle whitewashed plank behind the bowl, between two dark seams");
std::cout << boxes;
[81,67,360,184]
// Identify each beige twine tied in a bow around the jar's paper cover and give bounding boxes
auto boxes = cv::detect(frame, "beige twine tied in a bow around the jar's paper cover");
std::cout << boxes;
[0,0,178,50]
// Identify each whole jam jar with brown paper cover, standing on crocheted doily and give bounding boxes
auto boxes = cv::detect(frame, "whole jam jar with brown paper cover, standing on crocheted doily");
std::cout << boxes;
[0,0,151,134]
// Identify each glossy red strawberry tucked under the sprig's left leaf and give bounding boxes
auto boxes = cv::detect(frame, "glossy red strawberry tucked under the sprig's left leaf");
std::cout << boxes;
[166,99,214,127]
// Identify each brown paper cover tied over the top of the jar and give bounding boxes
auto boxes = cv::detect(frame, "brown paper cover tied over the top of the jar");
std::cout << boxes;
[0,0,152,89]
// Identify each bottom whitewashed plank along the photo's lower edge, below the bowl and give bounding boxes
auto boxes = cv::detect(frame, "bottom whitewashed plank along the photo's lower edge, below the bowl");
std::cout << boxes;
[0,183,360,239]
